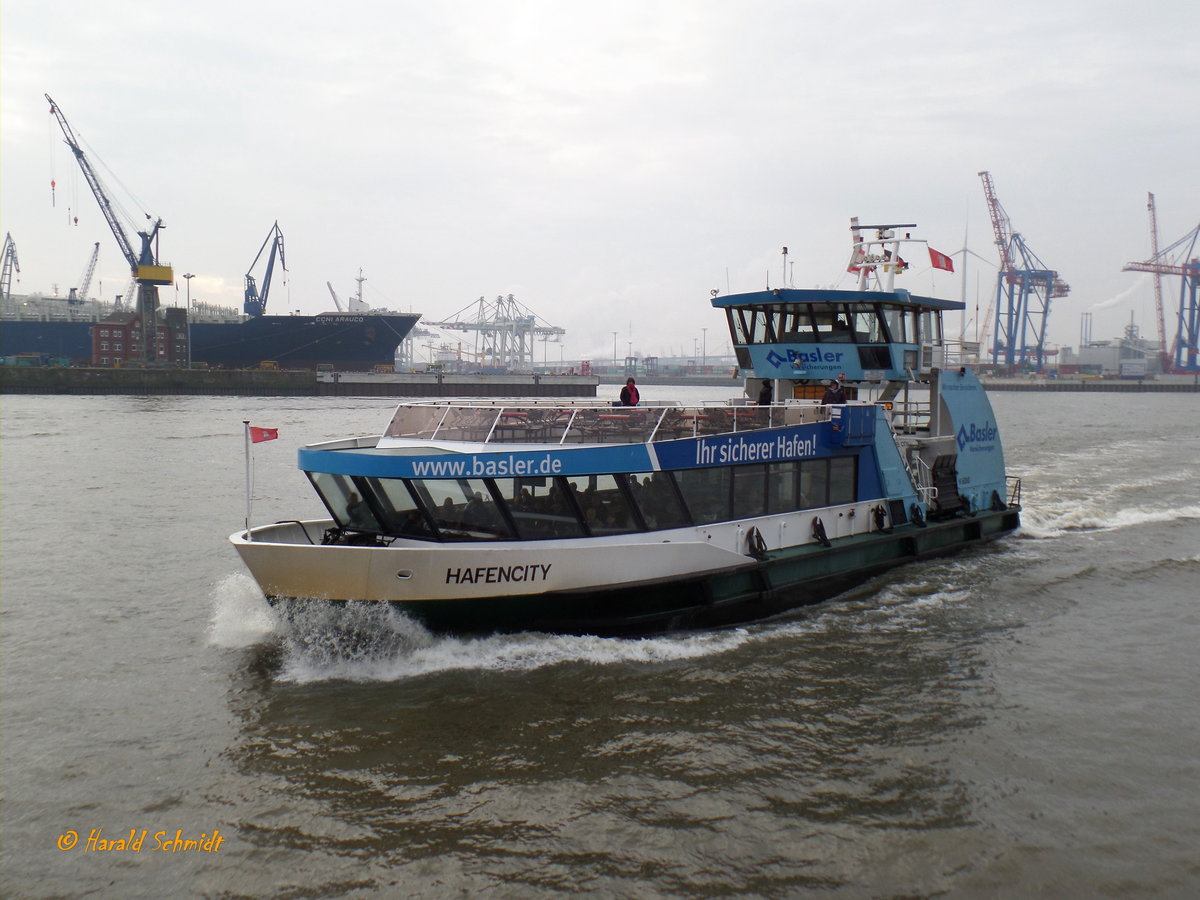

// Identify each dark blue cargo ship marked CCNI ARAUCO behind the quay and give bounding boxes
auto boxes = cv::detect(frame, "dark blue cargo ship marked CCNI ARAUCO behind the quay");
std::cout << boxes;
[0,294,420,372]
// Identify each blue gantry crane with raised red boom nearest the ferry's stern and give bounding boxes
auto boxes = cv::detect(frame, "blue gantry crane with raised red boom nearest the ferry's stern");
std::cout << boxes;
[979,172,1070,368]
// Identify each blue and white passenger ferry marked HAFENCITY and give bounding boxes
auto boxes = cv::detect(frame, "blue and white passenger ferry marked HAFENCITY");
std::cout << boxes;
[230,223,1020,635]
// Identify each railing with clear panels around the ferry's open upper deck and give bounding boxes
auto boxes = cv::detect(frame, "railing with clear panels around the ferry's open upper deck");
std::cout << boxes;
[380,401,844,445]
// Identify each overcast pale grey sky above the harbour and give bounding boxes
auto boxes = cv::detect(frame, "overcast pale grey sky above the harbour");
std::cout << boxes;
[2,0,1200,359]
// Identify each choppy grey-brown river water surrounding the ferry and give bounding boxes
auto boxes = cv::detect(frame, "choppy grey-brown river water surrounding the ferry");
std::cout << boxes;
[0,389,1200,898]
